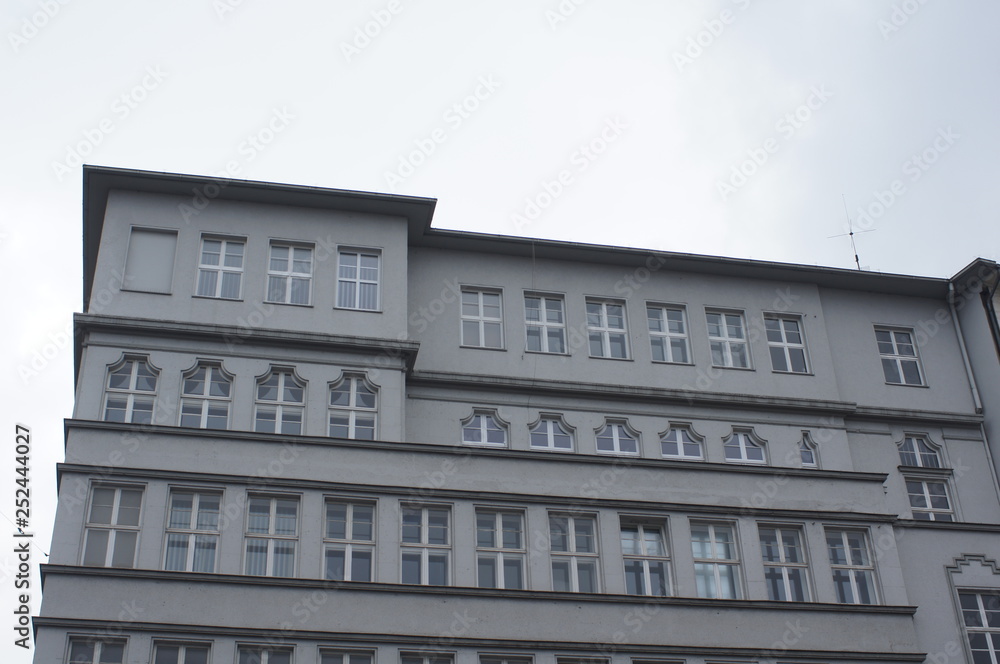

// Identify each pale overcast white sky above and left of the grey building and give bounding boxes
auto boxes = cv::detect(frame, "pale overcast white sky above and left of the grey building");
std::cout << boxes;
[0,0,1000,664]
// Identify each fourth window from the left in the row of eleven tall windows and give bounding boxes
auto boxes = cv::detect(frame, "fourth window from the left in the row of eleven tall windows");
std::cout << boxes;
[323,500,375,581]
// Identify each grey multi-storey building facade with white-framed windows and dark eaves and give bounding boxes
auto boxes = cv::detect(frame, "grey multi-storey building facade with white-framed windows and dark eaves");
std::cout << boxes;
[34,168,1000,664]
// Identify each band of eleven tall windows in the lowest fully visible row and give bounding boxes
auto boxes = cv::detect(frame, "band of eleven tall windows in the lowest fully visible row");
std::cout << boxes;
[81,483,900,604]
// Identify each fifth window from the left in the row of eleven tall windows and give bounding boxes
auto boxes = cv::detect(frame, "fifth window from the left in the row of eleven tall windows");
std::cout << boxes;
[400,507,451,586]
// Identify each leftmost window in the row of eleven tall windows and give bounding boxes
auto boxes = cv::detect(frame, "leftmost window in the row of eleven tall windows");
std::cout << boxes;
[83,486,142,567]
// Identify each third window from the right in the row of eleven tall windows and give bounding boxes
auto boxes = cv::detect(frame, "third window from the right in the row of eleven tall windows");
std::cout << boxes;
[691,522,740,599]
